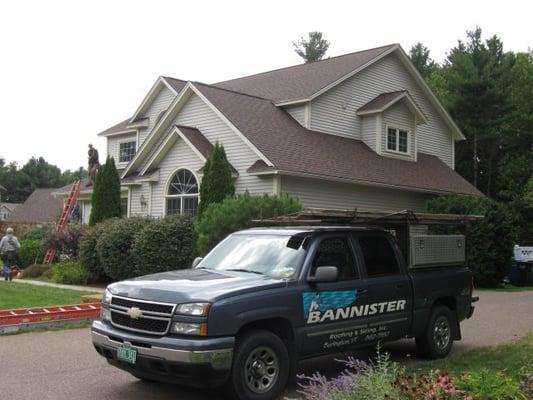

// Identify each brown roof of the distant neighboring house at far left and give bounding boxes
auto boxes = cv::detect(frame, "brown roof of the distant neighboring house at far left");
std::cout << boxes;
[9,189,63,223]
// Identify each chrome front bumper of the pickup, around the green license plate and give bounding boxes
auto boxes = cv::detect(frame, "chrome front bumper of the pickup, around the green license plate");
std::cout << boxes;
[91,320,235,386]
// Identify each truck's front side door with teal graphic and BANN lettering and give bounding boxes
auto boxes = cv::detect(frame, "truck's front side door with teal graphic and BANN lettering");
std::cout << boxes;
[299,233,368,355]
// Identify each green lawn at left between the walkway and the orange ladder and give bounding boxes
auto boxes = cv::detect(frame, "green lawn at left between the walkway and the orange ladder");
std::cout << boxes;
[0,280,97,310]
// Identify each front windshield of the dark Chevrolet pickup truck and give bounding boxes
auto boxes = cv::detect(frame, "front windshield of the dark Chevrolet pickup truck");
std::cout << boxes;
[198,234,305,279]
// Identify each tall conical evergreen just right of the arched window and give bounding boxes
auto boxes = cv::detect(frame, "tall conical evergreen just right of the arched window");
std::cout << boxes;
[198,143,235,217]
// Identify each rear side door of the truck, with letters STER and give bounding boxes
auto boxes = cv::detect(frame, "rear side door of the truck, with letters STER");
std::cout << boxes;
[354,232,412,342]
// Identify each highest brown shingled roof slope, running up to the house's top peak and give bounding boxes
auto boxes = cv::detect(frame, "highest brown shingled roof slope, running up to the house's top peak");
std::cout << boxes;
[214,44,395,103]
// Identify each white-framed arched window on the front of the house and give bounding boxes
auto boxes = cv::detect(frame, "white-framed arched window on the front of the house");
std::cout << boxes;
[166,169,198,216]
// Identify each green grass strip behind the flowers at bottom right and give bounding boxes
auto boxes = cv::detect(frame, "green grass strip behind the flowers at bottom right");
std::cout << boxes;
[413,334,533,378]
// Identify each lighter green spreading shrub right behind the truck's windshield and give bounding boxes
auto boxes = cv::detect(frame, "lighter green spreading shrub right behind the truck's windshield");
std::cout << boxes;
[195,193,302,254]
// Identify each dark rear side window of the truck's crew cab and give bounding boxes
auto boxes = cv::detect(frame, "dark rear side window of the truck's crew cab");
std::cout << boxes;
[359,236,400,277]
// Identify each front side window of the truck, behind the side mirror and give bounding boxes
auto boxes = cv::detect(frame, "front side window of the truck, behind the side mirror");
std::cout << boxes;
[311,238,357,280]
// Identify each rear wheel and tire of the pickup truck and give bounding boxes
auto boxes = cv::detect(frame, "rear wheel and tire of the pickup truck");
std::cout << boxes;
[416,304,454,359]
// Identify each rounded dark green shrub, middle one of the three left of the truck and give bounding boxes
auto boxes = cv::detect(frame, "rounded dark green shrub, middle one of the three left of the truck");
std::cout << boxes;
[96,217,153,280]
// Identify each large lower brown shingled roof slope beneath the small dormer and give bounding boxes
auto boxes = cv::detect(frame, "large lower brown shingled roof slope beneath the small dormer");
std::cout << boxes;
[195,84,480,195]
